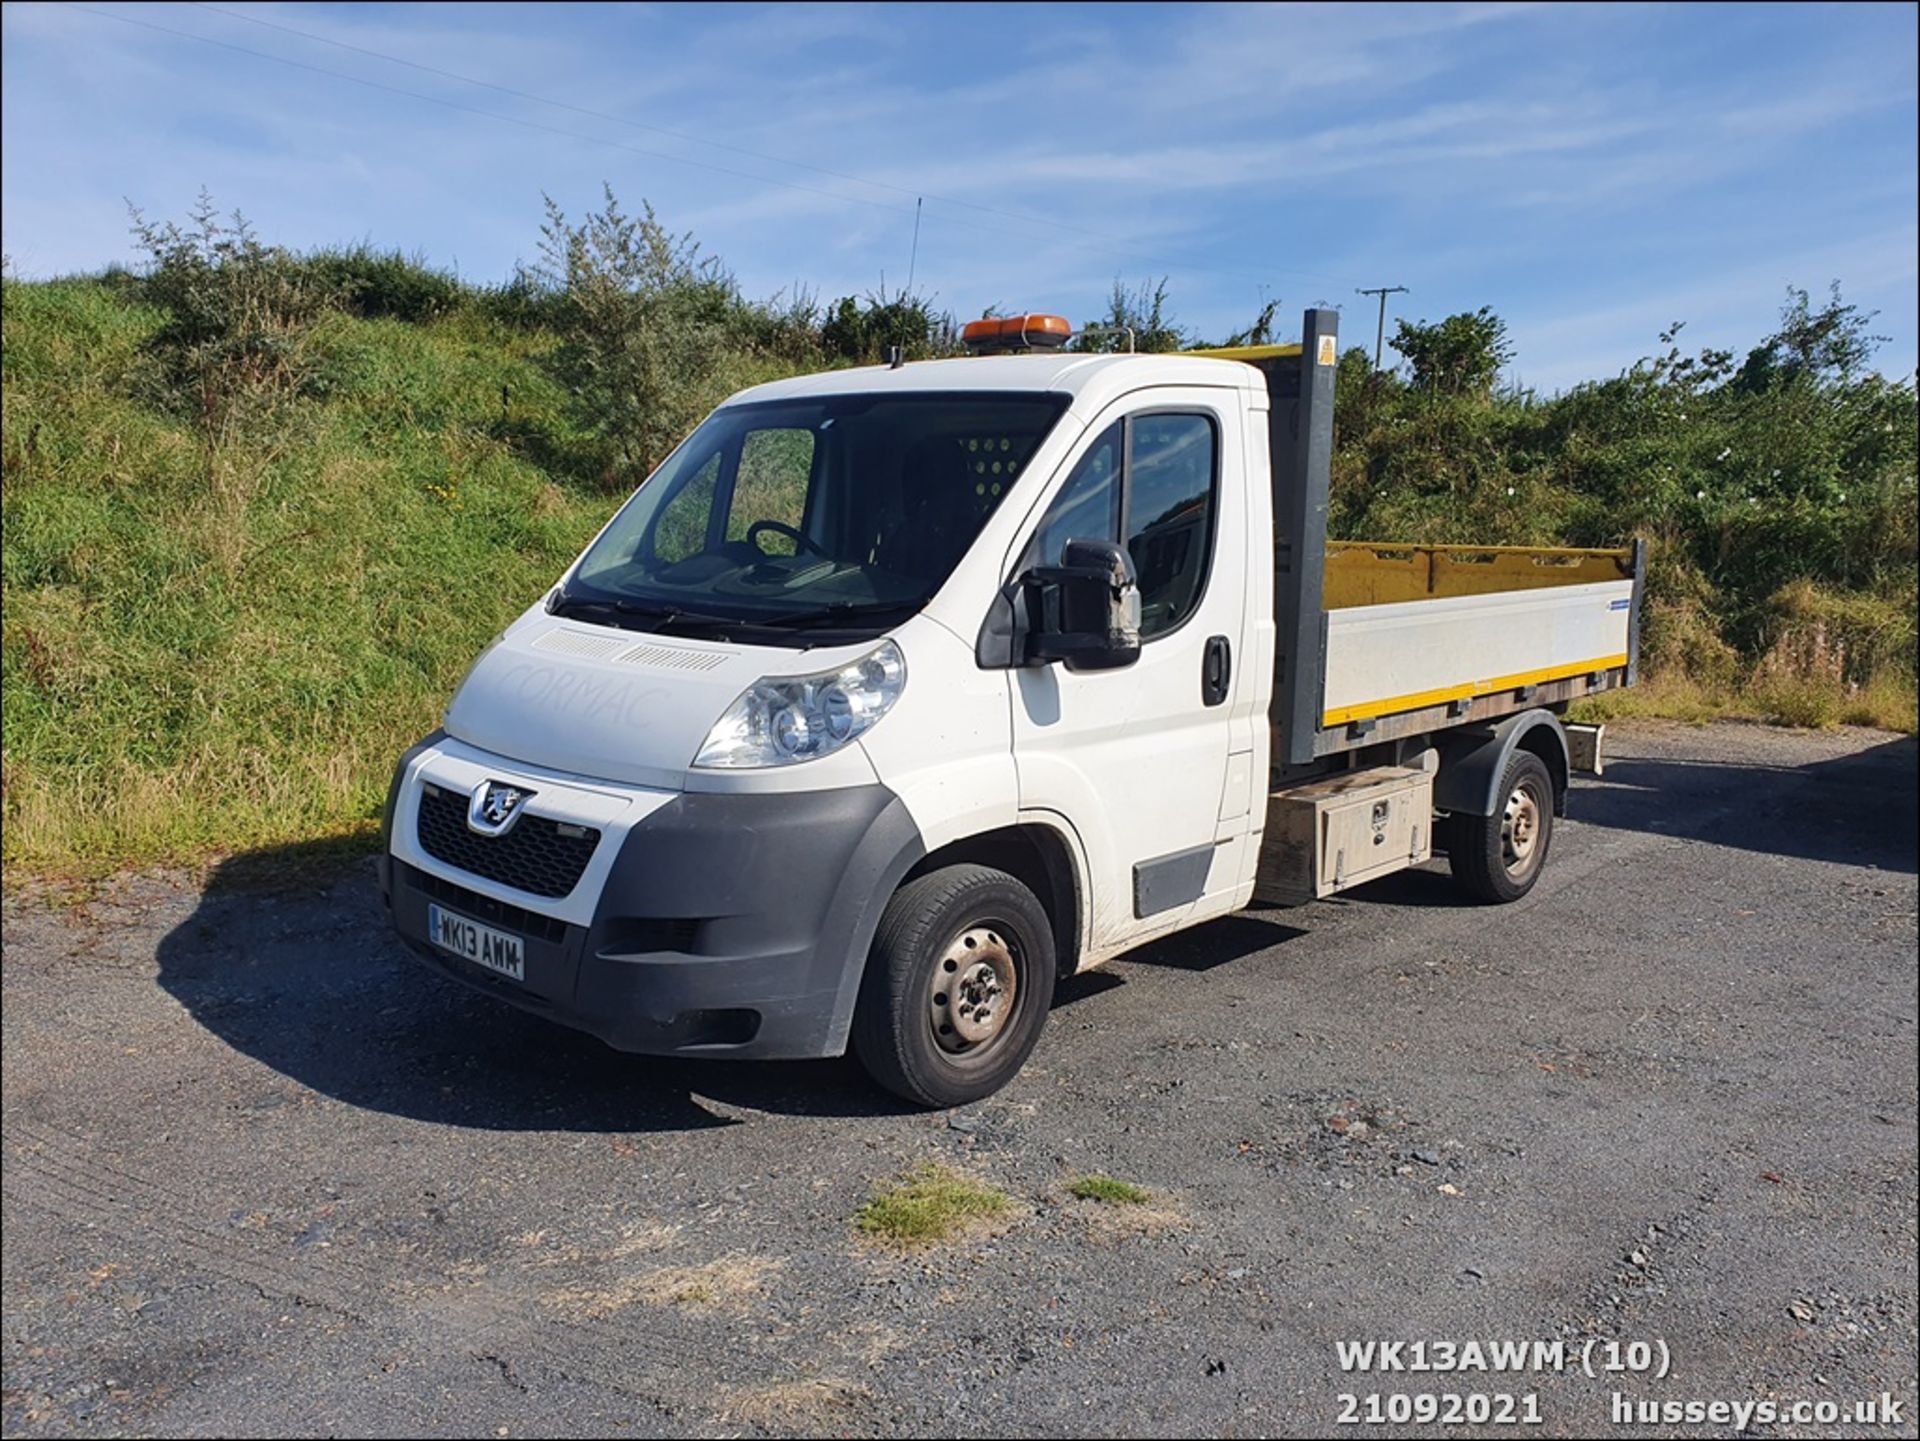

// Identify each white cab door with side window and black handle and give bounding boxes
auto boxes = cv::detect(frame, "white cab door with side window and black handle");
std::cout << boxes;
[1012,388,1254,959]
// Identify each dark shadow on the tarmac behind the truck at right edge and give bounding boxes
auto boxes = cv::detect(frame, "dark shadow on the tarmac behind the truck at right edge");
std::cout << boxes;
[1569,737,1920,875]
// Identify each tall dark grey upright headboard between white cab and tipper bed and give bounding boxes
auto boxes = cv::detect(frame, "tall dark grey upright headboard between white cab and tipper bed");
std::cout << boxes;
[1267,309,1340,766]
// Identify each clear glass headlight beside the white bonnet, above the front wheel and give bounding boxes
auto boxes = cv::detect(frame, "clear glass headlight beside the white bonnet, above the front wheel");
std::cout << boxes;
[693,641,906,769]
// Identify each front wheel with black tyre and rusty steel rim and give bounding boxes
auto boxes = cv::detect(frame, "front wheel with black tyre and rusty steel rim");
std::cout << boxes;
[852,865,1054,1107]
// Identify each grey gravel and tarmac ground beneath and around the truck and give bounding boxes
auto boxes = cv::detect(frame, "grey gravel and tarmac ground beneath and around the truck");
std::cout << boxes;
[0,723,1920,1435]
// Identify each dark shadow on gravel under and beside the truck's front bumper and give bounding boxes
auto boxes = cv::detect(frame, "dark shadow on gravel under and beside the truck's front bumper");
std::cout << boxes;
[157,846,912,1132]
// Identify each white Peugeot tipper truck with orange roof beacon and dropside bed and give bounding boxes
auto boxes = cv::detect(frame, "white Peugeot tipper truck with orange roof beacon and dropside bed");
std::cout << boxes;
[382,309,1645,1105]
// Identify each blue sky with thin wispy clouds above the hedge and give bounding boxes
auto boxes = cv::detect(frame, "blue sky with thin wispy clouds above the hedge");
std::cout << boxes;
[0,0,1920,390]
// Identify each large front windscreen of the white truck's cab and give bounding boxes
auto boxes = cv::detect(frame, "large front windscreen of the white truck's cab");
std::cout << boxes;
[553,393,1068,639]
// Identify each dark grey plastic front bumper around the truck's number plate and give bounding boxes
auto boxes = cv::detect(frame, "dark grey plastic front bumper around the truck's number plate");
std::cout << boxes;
[380,756,924,1057]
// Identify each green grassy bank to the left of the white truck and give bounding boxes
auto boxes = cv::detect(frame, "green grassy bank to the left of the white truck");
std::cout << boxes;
[4,282,609,867]
